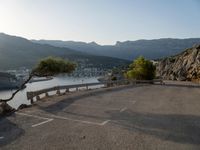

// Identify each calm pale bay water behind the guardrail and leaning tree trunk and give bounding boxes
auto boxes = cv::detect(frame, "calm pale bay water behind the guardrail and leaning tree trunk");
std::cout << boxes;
[0,76,98,108]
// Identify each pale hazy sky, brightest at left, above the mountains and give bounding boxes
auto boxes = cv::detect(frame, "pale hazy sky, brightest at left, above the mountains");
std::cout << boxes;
[0,0,200,44]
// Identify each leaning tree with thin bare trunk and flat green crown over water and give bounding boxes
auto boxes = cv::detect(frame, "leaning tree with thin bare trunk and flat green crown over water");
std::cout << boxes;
[0,57,76,103]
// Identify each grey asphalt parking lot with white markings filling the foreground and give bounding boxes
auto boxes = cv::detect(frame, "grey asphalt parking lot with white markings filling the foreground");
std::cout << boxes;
[0,85,200,150]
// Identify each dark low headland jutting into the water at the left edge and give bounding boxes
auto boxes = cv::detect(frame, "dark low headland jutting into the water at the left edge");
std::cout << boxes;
[0,72,24,90]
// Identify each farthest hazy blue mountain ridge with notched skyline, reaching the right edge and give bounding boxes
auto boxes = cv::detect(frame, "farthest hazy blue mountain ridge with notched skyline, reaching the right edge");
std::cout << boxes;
[33,38,200,60]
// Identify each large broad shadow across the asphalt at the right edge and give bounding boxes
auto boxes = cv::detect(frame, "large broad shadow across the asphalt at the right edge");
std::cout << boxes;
[107,110,200,145]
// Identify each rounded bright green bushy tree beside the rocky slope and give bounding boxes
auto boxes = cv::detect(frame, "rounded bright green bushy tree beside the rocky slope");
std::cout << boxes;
[125,56,156,80]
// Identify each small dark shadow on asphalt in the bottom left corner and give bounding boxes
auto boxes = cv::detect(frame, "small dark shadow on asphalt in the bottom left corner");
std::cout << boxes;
[0,116,25,147]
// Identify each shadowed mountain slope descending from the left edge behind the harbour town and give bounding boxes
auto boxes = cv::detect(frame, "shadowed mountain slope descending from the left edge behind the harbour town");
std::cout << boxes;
[0,33,128,70]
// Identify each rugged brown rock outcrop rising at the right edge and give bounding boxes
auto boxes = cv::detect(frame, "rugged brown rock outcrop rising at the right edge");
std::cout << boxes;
[157,45,200,82]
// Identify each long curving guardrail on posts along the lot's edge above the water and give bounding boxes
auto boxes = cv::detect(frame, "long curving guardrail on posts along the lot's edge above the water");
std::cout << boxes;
[26,79,164,103]
